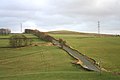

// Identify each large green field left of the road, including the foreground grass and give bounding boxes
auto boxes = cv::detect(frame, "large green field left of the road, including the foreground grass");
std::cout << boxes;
[0,34,120,80]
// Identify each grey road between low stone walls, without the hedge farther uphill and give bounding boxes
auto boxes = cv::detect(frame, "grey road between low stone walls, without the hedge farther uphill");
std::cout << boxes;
[52,40,100,72]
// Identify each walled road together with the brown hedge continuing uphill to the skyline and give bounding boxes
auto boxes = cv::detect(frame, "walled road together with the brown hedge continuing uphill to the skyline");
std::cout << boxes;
[25,29,101,72]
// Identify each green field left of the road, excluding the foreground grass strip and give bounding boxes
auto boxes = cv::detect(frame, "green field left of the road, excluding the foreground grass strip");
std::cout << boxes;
[0,34,81,79]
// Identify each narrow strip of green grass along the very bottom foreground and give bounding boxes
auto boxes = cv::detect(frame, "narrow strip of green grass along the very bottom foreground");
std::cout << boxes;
[1,72,120,80]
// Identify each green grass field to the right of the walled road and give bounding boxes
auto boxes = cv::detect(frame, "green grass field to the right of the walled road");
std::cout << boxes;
[51,31,120,72]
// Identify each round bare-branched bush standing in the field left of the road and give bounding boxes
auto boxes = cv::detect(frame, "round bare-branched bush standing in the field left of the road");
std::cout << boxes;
[9,34,32,48]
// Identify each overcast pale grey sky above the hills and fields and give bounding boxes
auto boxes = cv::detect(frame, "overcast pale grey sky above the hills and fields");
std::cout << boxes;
[0,0,120,34]
